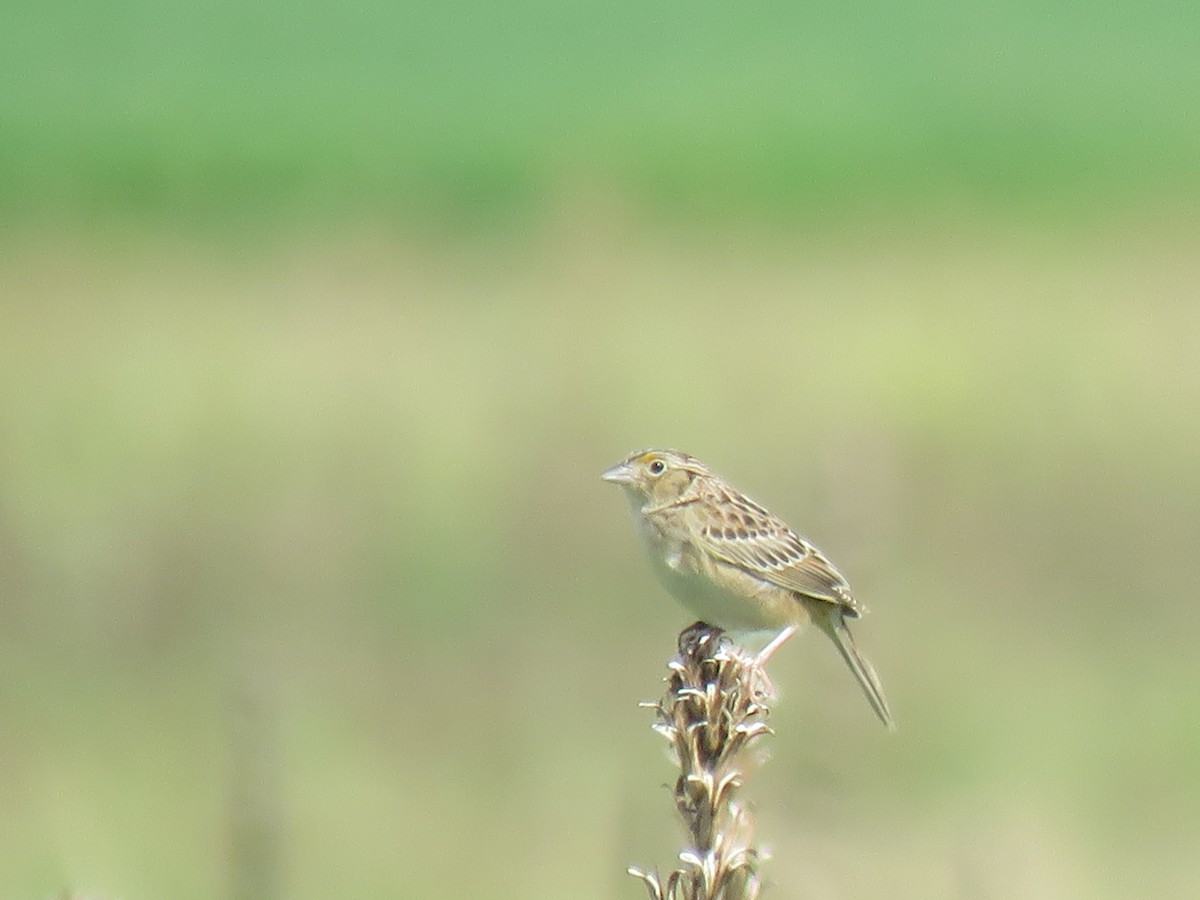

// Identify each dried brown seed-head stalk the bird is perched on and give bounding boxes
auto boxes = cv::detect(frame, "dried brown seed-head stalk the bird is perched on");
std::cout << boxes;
[629,623,772,900]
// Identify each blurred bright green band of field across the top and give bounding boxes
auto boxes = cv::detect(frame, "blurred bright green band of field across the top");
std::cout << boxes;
[0,0,1200,229]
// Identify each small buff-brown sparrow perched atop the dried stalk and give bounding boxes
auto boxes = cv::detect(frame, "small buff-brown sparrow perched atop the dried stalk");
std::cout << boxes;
[601,450,894,728]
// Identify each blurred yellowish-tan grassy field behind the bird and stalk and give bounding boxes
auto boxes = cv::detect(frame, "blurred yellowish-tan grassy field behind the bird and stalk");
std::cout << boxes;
[0,220,1200,898]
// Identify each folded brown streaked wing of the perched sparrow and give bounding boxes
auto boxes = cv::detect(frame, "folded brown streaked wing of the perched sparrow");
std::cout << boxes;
[695,494,865,617]
